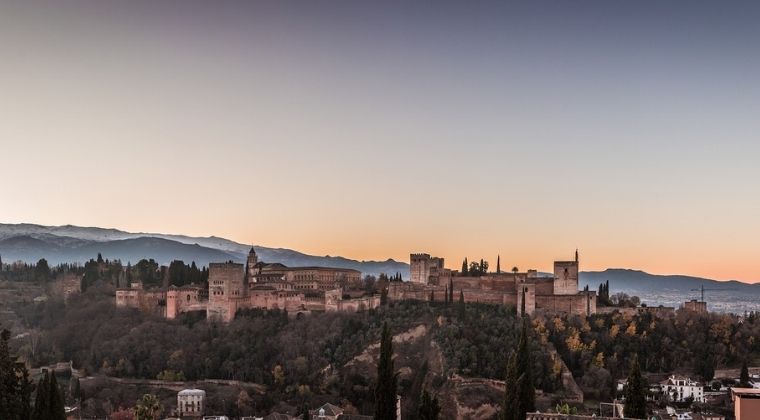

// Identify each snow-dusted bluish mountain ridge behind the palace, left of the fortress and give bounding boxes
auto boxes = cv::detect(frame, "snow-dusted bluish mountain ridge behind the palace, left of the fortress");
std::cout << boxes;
[0,224,409,278]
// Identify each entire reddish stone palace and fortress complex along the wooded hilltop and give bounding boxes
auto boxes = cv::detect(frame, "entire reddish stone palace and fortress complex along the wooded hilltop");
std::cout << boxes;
[116,248,597,322]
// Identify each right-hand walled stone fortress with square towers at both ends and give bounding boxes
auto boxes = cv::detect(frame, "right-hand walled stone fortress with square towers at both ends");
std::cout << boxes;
[388,251,596,315]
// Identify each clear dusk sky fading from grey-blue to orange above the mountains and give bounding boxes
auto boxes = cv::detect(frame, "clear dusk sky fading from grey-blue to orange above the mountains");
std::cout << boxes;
[0,0,760,281]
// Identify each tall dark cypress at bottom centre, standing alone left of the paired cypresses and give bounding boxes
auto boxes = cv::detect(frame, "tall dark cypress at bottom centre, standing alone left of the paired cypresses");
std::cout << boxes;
[375,322,398,420]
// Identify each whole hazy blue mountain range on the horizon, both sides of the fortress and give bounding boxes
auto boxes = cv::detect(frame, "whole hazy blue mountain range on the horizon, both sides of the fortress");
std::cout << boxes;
[0,224,760,302]
